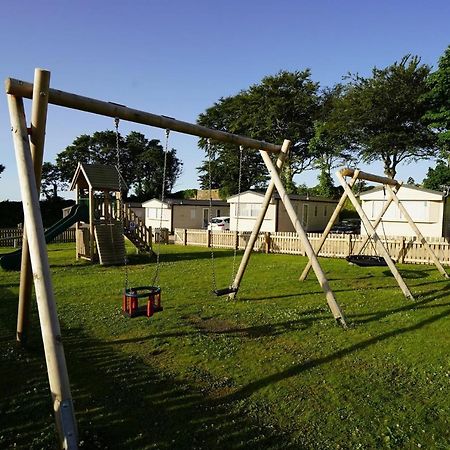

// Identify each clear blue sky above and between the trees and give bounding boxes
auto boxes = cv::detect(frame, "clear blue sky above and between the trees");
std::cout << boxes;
[0,0,450,200]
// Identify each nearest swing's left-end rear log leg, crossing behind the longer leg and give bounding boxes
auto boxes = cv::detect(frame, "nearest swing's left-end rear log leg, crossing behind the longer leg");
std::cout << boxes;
[16,69,50,344]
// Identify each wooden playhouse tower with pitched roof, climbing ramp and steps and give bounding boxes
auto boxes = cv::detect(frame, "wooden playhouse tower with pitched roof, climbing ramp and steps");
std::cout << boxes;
[70,163,152,265]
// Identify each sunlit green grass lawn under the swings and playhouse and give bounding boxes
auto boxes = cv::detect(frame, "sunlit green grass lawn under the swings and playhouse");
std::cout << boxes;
[0,244,450,449]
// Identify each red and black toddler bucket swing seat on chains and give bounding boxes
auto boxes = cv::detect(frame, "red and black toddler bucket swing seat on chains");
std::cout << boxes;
[122,286,163,317]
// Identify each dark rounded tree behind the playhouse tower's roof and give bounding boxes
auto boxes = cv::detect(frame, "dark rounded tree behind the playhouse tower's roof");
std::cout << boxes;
[56,131,183,200]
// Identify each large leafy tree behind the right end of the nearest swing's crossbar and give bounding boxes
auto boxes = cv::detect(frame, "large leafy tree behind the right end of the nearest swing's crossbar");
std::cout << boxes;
[198,69,318,194]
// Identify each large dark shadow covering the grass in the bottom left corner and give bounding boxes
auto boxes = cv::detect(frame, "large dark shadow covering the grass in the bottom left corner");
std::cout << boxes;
[0,307,290,449]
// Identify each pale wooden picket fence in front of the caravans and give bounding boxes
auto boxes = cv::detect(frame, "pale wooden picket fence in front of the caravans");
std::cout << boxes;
[174,228,450,265]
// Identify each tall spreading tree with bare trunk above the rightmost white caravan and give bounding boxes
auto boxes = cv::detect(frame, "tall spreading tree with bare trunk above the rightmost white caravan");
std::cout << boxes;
[330,55,436,178]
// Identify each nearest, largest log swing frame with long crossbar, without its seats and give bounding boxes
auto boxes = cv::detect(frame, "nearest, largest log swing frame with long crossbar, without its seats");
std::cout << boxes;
[5,69,346,449]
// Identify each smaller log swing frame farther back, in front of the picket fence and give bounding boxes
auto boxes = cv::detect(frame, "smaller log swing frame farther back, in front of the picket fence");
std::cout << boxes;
[299,168,449,300]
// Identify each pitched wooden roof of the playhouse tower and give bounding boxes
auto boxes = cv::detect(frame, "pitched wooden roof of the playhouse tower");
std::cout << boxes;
[70,163,127,192]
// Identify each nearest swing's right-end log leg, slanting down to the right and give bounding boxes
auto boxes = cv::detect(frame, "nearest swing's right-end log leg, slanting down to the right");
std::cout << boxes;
[260,151,346,327]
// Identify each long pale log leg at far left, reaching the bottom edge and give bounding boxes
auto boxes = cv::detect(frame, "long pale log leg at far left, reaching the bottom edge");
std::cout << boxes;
[8,95,78,449]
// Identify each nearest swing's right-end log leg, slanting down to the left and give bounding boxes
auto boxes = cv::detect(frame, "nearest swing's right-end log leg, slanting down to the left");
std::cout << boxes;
[228,140,291,299]
